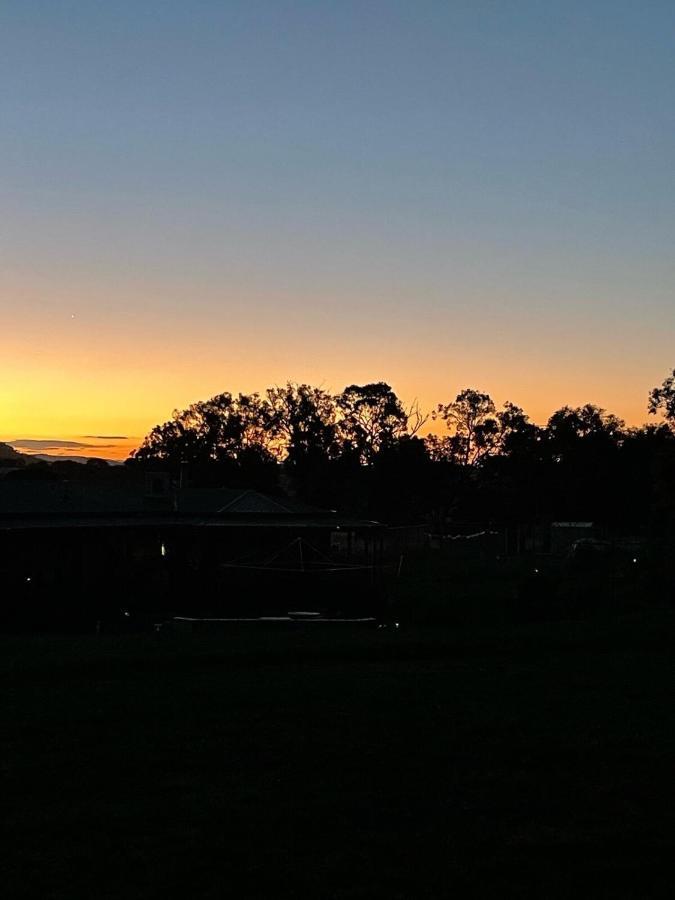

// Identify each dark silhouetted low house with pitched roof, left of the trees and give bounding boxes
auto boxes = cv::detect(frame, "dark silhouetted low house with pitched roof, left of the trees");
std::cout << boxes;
[0,475,384,627]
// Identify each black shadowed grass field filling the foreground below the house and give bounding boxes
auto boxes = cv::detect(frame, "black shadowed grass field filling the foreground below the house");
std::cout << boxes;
[0,613,675,900]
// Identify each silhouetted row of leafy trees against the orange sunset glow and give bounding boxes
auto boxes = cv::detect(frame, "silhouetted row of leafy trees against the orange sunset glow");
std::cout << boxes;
[128,371,675,522]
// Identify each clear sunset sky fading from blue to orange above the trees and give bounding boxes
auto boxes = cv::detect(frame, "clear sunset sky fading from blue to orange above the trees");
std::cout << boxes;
[0,0,675,458]
